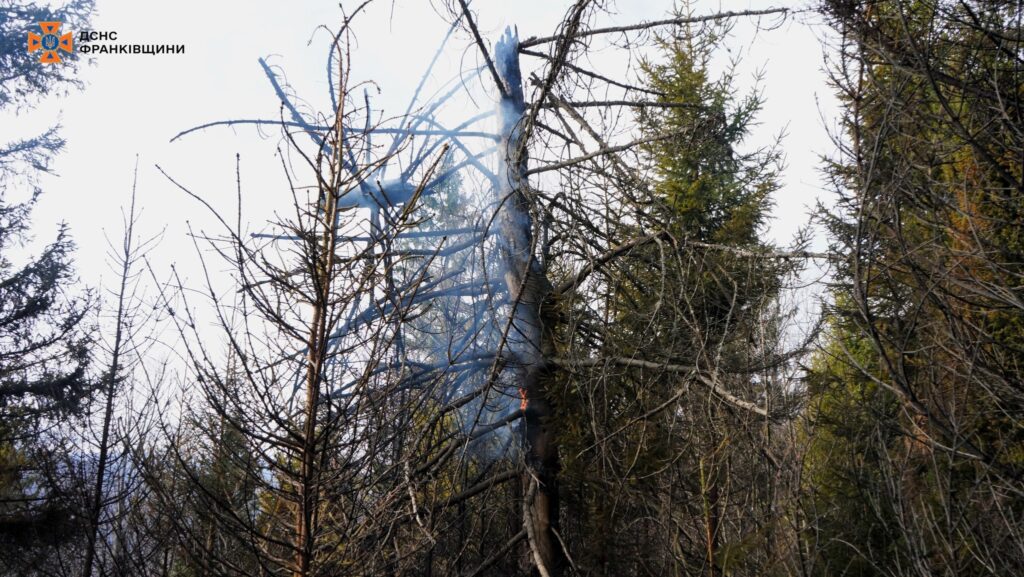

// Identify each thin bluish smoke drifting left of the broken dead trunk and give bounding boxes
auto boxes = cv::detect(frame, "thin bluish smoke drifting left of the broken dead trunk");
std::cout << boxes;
[218,23,539,460]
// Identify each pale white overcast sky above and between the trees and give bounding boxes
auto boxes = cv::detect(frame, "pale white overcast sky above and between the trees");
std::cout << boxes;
[9,0,837,303]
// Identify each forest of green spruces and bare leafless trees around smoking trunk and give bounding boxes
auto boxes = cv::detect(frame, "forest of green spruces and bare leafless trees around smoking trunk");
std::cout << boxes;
[0,0,1024,577]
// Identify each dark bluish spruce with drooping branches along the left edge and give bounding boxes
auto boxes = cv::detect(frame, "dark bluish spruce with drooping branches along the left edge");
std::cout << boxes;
[0,1,92,570]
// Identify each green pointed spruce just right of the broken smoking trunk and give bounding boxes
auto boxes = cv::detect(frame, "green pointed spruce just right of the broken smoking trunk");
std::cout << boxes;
[560,18,786,575]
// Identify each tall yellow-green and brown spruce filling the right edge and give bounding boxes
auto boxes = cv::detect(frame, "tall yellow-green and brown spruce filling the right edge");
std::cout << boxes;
[805,0,1024,575]
